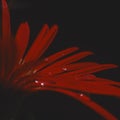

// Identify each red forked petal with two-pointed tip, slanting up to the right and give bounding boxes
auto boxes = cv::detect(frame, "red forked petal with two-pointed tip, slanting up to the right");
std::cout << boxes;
[24,25,58,62]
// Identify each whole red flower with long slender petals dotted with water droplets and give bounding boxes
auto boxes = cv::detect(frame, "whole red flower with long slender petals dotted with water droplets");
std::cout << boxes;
[0,0,120,120]
